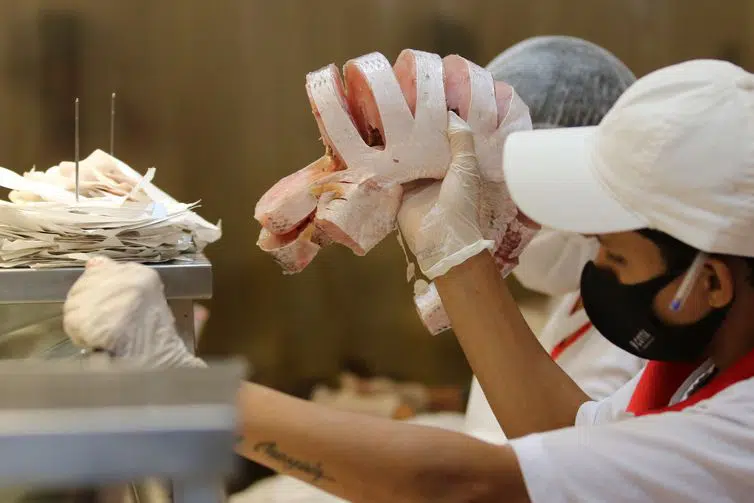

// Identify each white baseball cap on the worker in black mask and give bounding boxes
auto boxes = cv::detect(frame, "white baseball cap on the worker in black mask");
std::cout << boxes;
[503,60,754,257]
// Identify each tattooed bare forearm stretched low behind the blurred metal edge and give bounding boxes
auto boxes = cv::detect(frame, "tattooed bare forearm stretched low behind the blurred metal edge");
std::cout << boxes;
[238,383,526,502]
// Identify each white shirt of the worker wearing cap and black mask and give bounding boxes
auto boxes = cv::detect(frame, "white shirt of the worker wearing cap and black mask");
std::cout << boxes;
[510,366,754,503]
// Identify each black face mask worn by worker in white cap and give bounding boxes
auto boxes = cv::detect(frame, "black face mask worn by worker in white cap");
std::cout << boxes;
[581,262,730,362]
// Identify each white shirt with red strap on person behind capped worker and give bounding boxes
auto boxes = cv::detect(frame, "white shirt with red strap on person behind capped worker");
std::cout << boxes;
[465,292,644,444]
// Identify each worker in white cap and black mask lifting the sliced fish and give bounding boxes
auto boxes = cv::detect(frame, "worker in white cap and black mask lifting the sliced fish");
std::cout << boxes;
[64,54,754,503]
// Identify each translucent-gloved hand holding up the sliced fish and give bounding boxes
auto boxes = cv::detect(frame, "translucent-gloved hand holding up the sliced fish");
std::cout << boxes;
[398,112,495,279]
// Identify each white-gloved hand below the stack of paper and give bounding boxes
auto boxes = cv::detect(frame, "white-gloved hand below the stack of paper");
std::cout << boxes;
[63,258,206,367]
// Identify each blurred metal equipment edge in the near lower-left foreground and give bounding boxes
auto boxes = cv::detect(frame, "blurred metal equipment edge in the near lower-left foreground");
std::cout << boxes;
[0,359,245,503]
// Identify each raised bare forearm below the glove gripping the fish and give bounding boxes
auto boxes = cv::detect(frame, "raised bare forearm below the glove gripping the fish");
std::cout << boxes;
[436,252,589,438]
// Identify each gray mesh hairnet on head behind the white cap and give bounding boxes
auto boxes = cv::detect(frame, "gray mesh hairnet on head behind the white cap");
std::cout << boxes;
[487,36,636,128]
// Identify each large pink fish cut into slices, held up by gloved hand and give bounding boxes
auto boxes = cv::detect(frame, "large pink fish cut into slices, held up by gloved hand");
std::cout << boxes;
[254,49,537,334]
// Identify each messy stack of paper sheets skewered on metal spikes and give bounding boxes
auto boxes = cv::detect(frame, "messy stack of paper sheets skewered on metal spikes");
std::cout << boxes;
[0,150,221,268]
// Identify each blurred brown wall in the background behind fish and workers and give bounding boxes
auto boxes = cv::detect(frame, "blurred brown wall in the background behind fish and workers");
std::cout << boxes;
[0,0,754,389]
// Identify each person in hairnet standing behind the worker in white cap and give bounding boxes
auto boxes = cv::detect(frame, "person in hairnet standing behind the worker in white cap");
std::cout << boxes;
[464,36,644,443]
